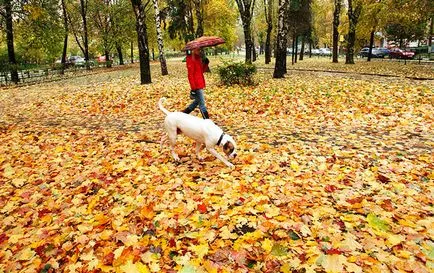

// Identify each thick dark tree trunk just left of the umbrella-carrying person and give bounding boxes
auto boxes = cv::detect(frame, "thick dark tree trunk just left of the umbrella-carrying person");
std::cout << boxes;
[131,0,152,84]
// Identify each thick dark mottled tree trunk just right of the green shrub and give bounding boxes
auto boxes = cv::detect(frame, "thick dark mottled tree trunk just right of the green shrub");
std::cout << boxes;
[273,0,289,78]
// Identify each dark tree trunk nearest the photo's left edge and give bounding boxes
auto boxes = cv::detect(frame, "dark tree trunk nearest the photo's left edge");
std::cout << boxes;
[5,0,20,83]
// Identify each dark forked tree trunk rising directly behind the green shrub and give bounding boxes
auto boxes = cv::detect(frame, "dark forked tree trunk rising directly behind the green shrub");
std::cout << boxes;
[236,0,255,63]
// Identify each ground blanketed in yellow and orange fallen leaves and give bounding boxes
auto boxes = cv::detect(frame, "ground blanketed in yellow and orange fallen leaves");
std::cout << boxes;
[0,58,434,273]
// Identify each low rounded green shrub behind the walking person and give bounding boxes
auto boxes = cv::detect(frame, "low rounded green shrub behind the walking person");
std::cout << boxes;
[217,62,256,85]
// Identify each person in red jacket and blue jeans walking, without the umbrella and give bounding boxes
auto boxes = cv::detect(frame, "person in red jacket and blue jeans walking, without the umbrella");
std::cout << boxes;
[183,48,209,119]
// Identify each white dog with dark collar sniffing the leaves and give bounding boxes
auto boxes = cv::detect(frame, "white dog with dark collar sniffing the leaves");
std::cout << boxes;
[158,98,237,168]
